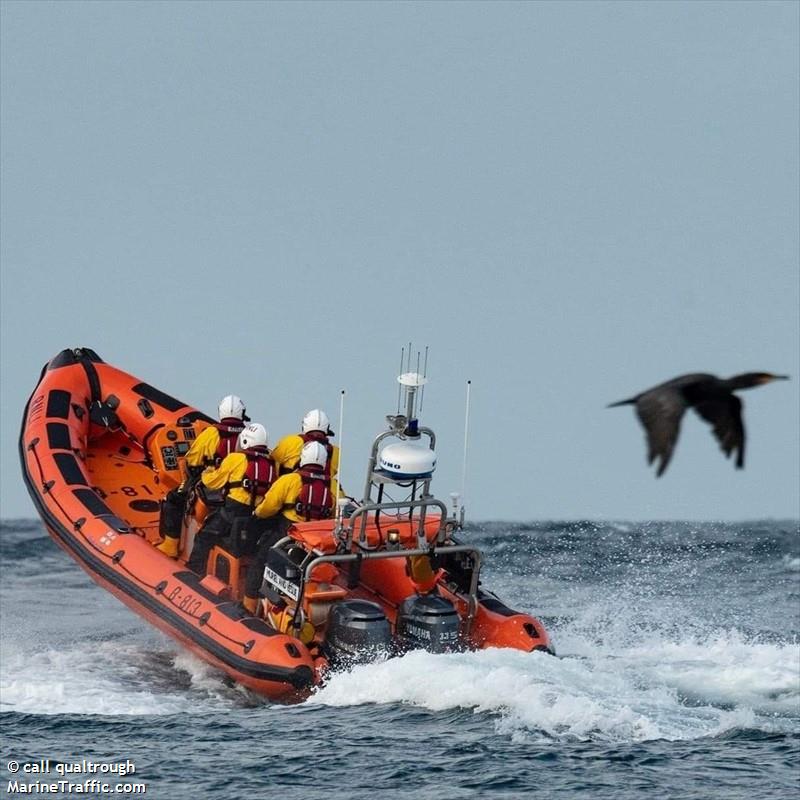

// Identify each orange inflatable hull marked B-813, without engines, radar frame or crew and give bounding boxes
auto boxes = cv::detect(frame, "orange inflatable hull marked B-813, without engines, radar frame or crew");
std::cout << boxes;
[19,349,551,701]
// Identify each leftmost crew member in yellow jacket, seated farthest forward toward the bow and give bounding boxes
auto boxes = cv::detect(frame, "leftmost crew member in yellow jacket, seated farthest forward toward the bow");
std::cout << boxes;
[158,394,250,558]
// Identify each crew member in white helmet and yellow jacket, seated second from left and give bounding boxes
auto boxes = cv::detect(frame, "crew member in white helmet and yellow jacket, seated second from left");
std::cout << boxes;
[186,422,278,576]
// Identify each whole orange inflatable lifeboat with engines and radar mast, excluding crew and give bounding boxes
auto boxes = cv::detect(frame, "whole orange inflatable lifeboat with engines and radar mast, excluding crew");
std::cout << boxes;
[19,348,553,701]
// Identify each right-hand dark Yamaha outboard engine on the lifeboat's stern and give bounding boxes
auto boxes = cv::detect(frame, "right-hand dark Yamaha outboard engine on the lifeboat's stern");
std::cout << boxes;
[397,594,462,653]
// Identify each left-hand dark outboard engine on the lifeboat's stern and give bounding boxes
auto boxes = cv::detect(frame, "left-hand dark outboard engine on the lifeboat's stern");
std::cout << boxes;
[322,600,392,669]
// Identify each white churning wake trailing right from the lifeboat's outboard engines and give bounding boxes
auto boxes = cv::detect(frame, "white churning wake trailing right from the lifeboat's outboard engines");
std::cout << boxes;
[308,636,800,742]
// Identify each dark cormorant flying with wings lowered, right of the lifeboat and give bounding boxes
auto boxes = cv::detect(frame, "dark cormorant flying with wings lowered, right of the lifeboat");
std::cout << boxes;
[608,372,789,477]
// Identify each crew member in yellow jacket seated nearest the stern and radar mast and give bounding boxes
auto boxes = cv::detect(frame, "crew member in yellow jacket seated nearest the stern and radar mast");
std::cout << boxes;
[242,442,341,614]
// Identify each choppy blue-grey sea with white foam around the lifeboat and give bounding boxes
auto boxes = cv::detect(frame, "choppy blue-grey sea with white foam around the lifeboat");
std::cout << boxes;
[0,520,800,800]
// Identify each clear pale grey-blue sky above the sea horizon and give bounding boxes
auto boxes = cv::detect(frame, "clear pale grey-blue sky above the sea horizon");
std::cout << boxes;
[0,0,800,520]
